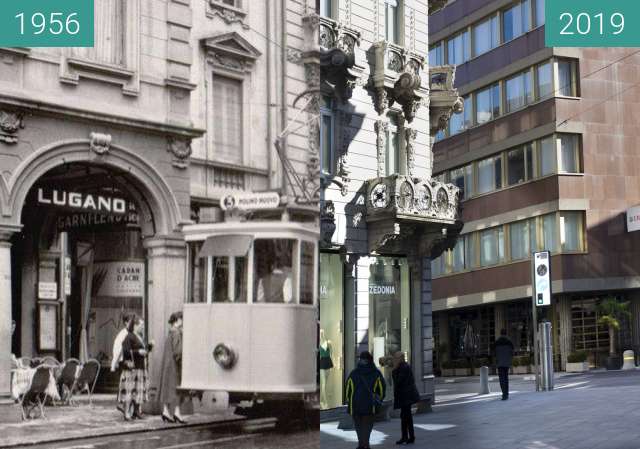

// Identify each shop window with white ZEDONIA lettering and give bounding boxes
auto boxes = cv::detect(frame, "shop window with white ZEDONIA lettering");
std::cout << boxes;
[369,257,411,398]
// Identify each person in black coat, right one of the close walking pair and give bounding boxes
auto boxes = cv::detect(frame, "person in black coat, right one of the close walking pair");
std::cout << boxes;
[391,352,420,444]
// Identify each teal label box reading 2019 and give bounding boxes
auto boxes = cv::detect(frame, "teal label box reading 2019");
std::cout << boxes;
[545,0,640,47]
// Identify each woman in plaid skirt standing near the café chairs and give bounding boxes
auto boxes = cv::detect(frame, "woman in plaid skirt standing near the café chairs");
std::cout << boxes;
[118,315,149,421]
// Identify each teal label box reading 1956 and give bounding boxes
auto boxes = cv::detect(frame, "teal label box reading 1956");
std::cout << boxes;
[0,0,94,47]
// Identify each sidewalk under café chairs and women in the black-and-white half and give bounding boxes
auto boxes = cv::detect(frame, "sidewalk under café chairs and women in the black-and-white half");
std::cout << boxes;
[0,395,245,448]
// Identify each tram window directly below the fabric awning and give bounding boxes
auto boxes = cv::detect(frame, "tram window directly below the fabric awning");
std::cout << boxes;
[211,256,247,302]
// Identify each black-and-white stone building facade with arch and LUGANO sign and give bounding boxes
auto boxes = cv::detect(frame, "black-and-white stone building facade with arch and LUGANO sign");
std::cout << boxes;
[0,0,319,408]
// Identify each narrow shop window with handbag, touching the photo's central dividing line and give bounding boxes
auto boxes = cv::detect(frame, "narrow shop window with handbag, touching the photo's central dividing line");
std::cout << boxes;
[318,253,344,410]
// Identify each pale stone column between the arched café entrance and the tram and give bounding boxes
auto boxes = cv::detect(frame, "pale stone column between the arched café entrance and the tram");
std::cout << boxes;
[144,236,187,414]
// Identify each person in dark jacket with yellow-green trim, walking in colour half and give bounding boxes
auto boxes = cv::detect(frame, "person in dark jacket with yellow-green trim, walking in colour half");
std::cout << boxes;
[345,351,387,449]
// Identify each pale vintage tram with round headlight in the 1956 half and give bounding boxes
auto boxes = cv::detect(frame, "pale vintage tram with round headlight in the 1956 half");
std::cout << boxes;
[181,203,319,410]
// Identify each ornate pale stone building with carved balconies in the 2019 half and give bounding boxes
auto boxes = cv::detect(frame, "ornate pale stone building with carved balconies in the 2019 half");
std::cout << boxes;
[319,0,460,413]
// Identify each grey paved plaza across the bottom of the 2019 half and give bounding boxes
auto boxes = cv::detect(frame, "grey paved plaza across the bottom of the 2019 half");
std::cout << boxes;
[320,372,640,449]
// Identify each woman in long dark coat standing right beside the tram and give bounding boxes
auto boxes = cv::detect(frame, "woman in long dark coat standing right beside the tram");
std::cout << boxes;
[159,312,185,424]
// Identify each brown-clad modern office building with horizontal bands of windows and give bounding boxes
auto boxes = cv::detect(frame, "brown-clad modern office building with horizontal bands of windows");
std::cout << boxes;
[430,0,640,369]
